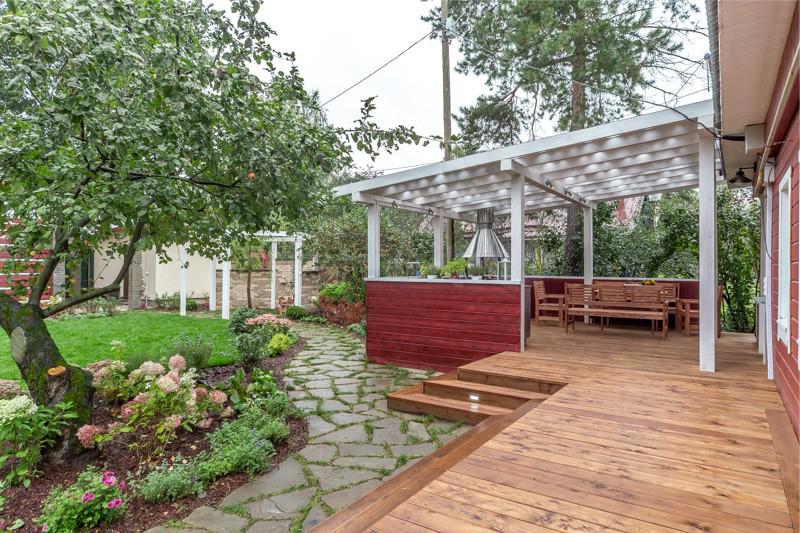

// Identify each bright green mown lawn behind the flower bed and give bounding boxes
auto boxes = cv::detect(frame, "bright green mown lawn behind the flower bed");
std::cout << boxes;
[0,311,233,379]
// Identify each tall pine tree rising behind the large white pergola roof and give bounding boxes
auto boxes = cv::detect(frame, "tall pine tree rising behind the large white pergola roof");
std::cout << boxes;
[429,0,697,273]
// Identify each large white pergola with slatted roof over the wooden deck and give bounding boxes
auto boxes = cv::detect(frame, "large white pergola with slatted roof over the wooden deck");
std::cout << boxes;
[335,101,721,371]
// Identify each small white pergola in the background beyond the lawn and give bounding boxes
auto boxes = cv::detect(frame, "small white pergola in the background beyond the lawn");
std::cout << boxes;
[178,231,305,320]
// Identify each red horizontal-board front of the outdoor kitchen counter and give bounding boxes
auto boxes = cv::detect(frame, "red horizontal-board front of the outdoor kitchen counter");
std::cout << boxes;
[367,280,520,371]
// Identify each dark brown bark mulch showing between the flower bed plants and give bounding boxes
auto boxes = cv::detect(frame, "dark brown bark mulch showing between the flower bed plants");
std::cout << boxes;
[0,339,308,533]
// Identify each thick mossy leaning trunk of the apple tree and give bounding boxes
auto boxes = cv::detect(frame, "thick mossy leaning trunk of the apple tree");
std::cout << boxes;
[0,295,94,453]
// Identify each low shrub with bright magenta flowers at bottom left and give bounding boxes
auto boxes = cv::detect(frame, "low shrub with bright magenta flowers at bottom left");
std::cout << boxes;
[37,467,125,533]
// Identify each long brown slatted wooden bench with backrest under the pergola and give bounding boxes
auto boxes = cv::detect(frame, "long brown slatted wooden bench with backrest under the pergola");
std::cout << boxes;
[565,284,671,337]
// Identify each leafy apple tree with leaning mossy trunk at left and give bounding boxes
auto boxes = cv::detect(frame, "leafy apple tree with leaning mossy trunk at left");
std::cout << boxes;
[0,0,418,440]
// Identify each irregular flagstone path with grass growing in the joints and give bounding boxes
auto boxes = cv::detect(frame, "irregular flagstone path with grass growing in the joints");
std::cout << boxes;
[147,323,468,533]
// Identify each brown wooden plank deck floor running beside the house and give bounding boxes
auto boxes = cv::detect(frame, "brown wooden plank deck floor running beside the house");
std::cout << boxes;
[314,324,798,532]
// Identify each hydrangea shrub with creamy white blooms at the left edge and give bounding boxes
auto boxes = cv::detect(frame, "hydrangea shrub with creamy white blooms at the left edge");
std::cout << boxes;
[0,394,77,487]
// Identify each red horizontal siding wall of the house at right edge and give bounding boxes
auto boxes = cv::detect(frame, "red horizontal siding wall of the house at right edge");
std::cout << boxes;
[767,112,800,439]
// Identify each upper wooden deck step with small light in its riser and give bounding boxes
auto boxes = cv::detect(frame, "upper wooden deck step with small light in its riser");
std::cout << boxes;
[422,379,549,409]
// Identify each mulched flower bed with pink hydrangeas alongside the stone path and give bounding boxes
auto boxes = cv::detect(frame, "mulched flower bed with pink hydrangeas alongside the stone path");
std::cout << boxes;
[0,336,307,532]
